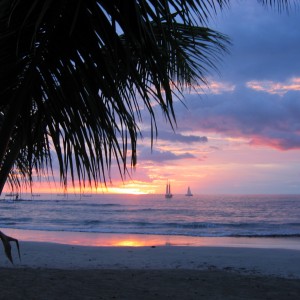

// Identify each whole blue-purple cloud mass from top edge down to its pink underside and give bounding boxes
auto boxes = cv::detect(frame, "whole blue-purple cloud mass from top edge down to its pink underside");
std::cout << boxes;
[138,1,300,151]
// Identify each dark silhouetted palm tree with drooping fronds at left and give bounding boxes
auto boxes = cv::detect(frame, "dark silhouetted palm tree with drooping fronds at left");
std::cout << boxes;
[0,0,288,262]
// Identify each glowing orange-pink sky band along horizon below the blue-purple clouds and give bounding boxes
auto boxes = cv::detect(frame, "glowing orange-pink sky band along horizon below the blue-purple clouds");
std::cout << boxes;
[0,135,299,195]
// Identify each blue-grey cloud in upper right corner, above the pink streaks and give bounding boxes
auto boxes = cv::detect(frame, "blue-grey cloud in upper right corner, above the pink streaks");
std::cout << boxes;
[212,1,300,84]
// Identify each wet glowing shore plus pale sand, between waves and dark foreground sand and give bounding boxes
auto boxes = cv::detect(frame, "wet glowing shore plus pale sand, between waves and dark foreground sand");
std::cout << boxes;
[0,229,300,279]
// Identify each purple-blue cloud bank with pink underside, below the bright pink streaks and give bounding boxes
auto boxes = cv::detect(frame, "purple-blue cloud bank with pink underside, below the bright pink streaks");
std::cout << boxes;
[178,87,300,150]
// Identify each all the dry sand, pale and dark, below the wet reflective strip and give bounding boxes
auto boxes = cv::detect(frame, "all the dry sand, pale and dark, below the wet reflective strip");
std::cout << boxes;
[0,242,300,300]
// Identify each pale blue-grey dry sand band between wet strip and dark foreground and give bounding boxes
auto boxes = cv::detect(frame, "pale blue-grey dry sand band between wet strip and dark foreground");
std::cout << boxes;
[1,242,300,279]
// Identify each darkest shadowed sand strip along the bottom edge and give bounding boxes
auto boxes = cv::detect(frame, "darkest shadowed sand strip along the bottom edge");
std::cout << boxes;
[0,268,300,300]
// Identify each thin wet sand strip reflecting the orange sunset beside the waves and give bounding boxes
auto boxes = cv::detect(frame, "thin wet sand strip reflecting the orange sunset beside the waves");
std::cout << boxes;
[0,228,300,250]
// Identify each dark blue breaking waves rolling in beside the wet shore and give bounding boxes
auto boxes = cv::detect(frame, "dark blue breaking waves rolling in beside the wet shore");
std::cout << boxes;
[0,218,300,238]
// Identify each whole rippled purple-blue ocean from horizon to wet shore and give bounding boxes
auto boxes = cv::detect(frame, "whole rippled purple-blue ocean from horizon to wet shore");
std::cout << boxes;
[0,194,300,237]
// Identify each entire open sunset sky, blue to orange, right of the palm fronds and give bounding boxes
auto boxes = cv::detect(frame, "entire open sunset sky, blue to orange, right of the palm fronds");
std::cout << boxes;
[5,1,300,194]
